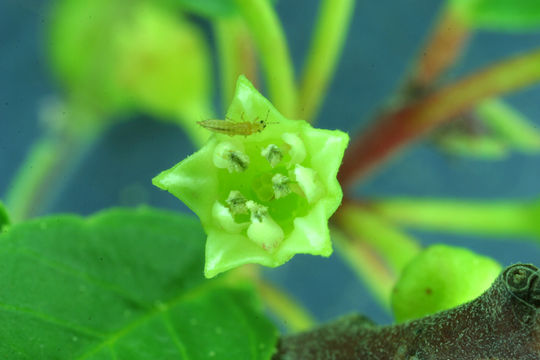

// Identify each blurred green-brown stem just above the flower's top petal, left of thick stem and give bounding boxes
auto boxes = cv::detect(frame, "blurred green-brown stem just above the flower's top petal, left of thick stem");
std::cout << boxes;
[213,17,257,109]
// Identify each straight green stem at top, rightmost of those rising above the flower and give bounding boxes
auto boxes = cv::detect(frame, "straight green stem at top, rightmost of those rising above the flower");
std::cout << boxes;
[299,0,355,121]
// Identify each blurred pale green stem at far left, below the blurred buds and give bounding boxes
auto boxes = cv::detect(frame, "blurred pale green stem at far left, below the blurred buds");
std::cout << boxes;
[6,126,101,223]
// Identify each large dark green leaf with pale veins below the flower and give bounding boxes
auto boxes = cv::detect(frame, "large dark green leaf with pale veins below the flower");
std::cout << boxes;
[0,208,277,360]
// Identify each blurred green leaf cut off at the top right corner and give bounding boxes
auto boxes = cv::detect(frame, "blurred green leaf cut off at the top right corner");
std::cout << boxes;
[450,0,540,30]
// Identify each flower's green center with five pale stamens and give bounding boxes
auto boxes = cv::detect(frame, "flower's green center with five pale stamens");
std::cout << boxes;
[213,133,323,252]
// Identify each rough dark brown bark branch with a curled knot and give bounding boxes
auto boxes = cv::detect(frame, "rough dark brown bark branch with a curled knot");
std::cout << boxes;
[273,264,540,360]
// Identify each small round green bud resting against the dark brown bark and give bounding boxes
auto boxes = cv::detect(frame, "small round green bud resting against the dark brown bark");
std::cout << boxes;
[391,245,502,322]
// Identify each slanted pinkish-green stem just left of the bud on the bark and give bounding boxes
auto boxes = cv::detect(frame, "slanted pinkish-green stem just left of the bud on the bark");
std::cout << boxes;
[332,228,397,311]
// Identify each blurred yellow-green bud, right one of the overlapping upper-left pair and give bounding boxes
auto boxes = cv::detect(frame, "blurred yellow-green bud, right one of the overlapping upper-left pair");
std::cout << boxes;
[116,2,211,118]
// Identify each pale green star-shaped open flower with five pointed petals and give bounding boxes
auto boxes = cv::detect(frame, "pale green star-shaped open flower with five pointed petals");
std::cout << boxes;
[152,76,349,277]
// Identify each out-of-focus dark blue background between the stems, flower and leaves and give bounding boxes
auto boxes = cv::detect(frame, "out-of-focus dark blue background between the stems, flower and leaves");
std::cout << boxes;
[0,0,540,323]
